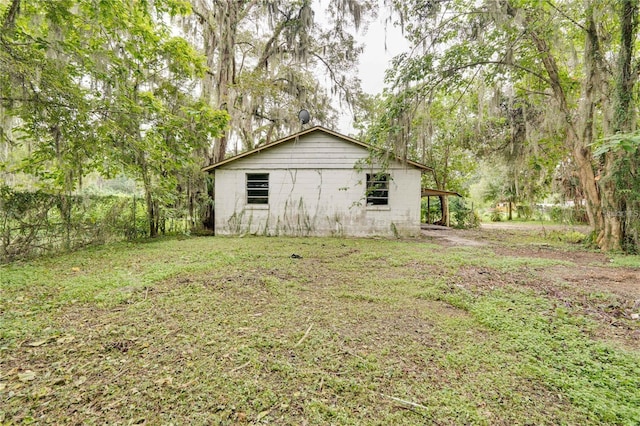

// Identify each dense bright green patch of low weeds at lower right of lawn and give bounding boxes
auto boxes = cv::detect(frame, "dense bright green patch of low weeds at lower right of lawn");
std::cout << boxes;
[468,291,640,424]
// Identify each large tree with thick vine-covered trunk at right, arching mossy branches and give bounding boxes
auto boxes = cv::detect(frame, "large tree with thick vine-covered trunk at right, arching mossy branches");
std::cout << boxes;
[380,0,638,250]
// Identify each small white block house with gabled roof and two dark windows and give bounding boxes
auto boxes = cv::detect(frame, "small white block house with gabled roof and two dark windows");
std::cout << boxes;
[204,127,431,236]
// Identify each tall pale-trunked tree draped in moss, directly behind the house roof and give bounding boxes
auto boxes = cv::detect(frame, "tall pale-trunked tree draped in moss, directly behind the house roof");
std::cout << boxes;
[185,0,374,163]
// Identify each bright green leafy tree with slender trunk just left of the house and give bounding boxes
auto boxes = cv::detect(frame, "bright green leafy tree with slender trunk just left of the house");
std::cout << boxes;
[78,2,228,237]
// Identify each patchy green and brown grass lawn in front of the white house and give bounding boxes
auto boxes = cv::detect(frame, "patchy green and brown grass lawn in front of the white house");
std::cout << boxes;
[0,230,640,425]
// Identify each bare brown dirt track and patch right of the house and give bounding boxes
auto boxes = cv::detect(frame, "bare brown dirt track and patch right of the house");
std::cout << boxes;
[422,222,640,349]
